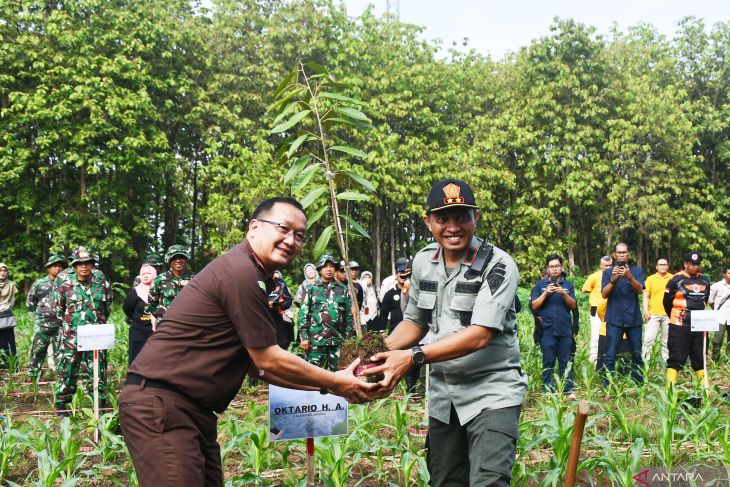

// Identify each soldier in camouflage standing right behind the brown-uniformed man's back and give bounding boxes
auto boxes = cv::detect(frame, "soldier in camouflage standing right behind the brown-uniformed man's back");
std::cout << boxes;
[146,245,195,326]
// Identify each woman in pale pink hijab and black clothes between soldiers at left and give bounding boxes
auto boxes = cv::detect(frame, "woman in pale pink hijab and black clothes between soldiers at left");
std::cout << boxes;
[122,264,157,365]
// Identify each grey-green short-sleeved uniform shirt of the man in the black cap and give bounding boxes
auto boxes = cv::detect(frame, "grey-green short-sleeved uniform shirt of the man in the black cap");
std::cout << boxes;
[403,237,527,425]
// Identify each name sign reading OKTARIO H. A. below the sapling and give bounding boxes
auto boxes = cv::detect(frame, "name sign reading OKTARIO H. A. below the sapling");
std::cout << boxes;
[269,385,347,441]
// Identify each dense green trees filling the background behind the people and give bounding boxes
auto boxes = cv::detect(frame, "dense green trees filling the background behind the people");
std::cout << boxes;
[0,0,730,288]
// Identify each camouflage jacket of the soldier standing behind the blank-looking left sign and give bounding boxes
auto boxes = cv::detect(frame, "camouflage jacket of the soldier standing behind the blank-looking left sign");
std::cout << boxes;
[53,269,112,340]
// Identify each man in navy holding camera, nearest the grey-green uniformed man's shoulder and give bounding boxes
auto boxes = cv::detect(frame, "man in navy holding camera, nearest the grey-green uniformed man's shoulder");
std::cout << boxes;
[530,254,576,394]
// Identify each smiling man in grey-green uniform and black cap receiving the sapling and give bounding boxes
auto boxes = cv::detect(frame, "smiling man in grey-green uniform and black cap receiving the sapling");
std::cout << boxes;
[366,179,527,487]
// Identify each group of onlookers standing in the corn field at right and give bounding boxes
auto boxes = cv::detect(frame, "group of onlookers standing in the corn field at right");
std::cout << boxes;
[530,242,730,394]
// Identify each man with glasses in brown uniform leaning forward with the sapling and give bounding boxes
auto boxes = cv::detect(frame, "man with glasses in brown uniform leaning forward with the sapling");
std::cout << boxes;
[119,198,377,487]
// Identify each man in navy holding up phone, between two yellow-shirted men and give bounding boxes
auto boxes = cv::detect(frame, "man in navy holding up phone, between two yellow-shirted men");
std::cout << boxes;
[601,242,644,385]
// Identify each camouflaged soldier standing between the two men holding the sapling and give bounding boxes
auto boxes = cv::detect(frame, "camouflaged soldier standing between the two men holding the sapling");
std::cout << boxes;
[299,254,355,370]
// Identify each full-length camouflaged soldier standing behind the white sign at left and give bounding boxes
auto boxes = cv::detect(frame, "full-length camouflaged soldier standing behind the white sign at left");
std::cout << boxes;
[53,247,112,414]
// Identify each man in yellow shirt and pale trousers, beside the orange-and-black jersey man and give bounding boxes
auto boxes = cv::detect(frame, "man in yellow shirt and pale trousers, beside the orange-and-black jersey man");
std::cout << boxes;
[641,258,672,363]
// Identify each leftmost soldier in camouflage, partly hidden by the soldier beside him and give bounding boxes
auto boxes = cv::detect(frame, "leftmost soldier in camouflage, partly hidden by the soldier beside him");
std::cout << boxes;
[25,254,66,380]
